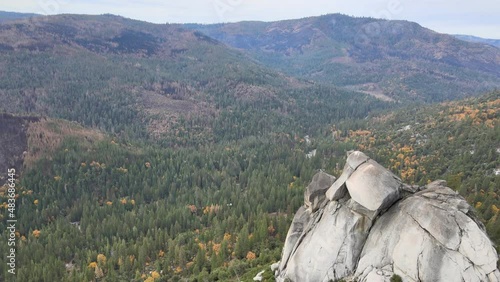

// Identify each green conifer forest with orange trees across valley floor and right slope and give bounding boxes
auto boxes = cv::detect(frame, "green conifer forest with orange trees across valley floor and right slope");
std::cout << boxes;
[0,92,500,281]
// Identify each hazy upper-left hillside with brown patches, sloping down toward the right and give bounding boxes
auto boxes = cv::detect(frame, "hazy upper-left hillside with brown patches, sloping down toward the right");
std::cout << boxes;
[0,15,387,142]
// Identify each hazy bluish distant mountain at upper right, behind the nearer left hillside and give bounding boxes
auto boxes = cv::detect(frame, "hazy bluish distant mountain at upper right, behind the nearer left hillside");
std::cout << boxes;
[185,14,500,101]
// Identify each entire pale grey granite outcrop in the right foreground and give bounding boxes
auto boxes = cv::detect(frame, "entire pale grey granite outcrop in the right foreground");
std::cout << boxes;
[275,152,500,281]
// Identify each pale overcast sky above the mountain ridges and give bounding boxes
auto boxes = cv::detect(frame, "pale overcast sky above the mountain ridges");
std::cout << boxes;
[0,0,500,39]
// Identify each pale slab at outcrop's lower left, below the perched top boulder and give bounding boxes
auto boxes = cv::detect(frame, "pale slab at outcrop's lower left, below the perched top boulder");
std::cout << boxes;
[278,202,371,281]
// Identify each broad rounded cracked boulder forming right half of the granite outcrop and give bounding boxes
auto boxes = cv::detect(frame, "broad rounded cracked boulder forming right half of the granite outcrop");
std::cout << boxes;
[356,187,498,281]
